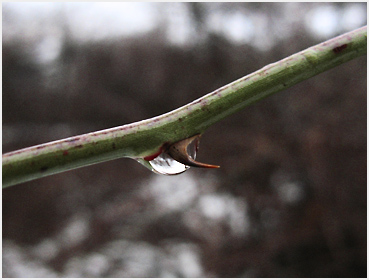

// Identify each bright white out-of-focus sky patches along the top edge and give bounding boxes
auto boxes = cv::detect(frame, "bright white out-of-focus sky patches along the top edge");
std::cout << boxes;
[3,2,366,61]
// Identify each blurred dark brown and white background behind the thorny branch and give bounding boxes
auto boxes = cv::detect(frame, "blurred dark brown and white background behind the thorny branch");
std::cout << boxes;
[2,2,367,277]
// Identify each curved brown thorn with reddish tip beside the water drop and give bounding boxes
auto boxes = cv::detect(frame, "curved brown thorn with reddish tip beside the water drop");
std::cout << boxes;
[168,134,220,168]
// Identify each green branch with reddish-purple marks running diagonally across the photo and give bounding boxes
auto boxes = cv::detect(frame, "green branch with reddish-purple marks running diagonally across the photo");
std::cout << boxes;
[3,26,367,187]
